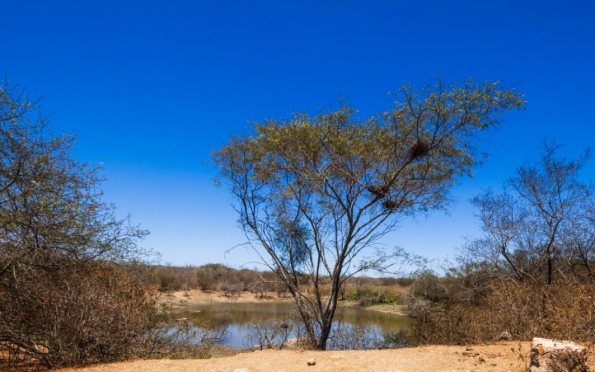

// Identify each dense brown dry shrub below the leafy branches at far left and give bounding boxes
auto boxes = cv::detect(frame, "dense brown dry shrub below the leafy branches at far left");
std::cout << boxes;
[0,262,157,369]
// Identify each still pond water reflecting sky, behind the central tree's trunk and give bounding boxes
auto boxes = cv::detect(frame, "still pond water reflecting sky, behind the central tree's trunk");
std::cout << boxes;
[180,302,409,348]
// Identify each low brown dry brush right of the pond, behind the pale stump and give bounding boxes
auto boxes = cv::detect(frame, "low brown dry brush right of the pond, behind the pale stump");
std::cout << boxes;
[409,278,595,344]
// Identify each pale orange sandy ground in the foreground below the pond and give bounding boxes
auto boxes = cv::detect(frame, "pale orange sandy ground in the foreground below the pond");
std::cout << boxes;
[60,342,544,372]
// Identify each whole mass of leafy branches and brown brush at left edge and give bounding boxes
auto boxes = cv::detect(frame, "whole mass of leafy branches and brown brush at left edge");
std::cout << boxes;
[0,83,200,370]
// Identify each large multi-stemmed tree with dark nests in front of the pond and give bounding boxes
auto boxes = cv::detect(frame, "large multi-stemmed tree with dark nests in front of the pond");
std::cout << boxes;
[213,80,523,350]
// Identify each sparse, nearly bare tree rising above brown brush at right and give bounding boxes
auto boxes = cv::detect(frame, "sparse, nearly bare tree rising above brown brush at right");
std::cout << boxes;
[465,142,595,284]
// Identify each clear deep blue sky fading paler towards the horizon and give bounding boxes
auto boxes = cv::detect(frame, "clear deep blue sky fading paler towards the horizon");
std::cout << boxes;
[0,0,595,267]
